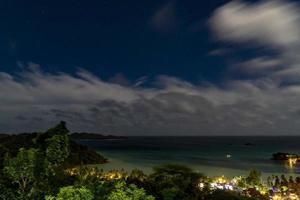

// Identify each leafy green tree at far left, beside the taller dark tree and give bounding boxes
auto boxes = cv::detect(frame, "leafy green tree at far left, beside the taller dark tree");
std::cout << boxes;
[4,148,37,199]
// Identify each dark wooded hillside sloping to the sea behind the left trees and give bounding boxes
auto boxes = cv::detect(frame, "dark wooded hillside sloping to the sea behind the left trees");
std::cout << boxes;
[0,122,107,170]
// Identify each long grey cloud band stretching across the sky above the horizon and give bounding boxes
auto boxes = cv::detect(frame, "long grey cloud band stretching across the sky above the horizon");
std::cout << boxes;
[0,66,300,135]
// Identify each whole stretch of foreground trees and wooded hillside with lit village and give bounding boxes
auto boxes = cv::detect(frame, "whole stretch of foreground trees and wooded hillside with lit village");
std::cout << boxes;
[0,122,300,200]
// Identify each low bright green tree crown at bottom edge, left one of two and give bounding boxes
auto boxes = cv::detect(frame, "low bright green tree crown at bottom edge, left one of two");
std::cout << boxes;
[46,186,94,200]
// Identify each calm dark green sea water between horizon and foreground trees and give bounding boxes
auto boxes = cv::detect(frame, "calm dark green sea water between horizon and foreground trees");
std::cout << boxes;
[80,137,300,176]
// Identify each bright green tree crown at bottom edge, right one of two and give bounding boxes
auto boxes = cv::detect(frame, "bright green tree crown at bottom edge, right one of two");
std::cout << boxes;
[107,182,155,200]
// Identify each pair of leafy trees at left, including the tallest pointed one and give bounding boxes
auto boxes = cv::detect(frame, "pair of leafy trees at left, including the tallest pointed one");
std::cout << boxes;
[2,122,69,200]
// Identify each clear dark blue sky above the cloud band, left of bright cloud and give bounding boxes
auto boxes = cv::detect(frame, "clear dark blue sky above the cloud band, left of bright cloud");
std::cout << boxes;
[0,0,227,82]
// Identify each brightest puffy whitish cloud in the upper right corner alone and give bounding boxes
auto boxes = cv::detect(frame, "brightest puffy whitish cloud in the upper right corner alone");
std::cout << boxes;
[210,1,300,49]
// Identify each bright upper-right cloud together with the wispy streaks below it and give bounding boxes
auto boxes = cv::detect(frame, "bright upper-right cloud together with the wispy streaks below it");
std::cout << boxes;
[209,0,300,83]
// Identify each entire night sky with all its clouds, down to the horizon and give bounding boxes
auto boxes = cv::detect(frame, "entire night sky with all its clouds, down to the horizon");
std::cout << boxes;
[0,0,300,135]
